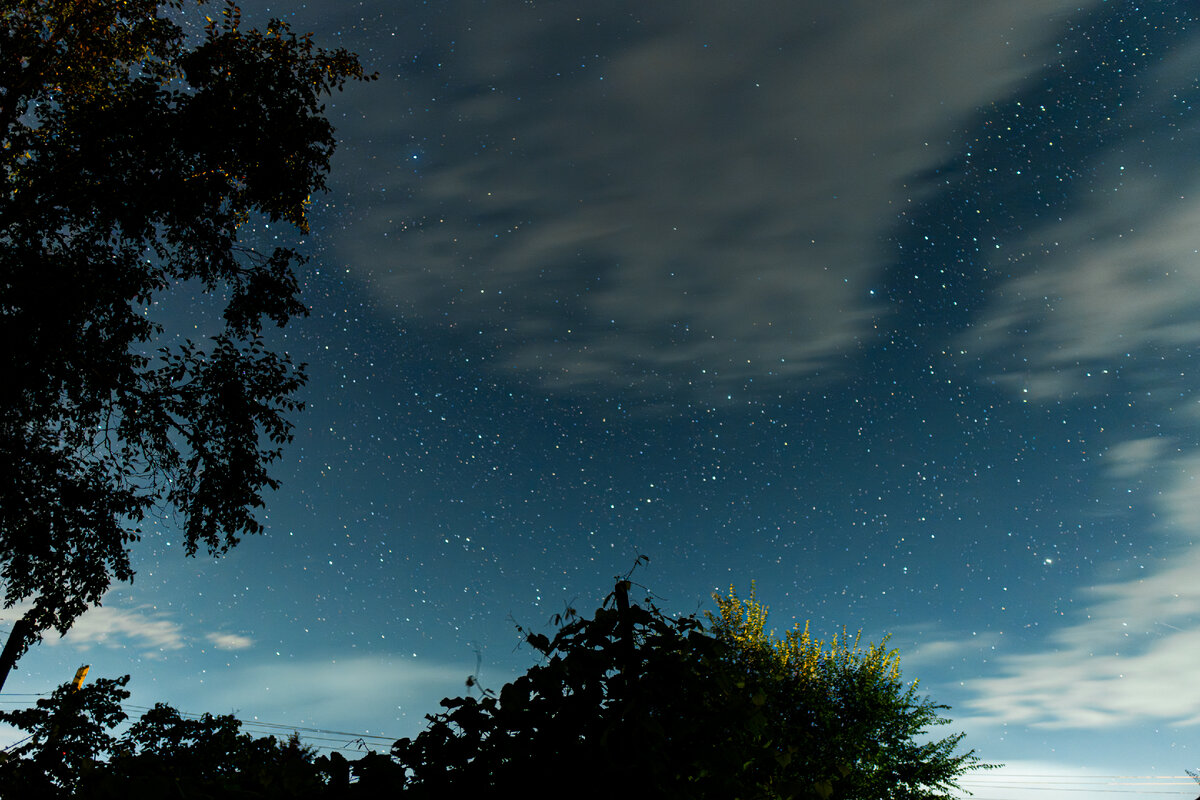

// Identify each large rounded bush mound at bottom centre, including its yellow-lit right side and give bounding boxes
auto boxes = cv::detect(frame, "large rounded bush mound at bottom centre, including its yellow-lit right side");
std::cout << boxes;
[392,581,982,800]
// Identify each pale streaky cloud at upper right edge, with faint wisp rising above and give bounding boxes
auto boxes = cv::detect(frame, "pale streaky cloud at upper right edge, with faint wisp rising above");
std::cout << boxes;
[961,36,1200,400]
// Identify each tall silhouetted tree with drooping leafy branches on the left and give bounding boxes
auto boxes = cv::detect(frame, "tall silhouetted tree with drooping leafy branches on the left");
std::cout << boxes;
[0,0,365,685]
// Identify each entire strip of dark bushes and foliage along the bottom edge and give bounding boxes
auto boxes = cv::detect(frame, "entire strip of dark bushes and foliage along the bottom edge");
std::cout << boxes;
[0,579,982,800]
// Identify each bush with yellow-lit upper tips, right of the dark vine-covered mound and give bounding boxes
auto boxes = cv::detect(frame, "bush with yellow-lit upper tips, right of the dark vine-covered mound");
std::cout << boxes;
[709,587,986,799]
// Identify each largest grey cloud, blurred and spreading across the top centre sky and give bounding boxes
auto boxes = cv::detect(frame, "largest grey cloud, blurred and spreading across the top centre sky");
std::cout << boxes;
[342,0,1076,396]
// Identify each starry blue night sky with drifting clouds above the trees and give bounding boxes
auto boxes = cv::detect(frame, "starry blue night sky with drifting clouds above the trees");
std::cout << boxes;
[0,0,1200,800]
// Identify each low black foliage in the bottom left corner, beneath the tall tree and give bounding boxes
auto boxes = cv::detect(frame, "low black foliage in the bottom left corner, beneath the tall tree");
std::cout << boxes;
[0,675,404,800]
